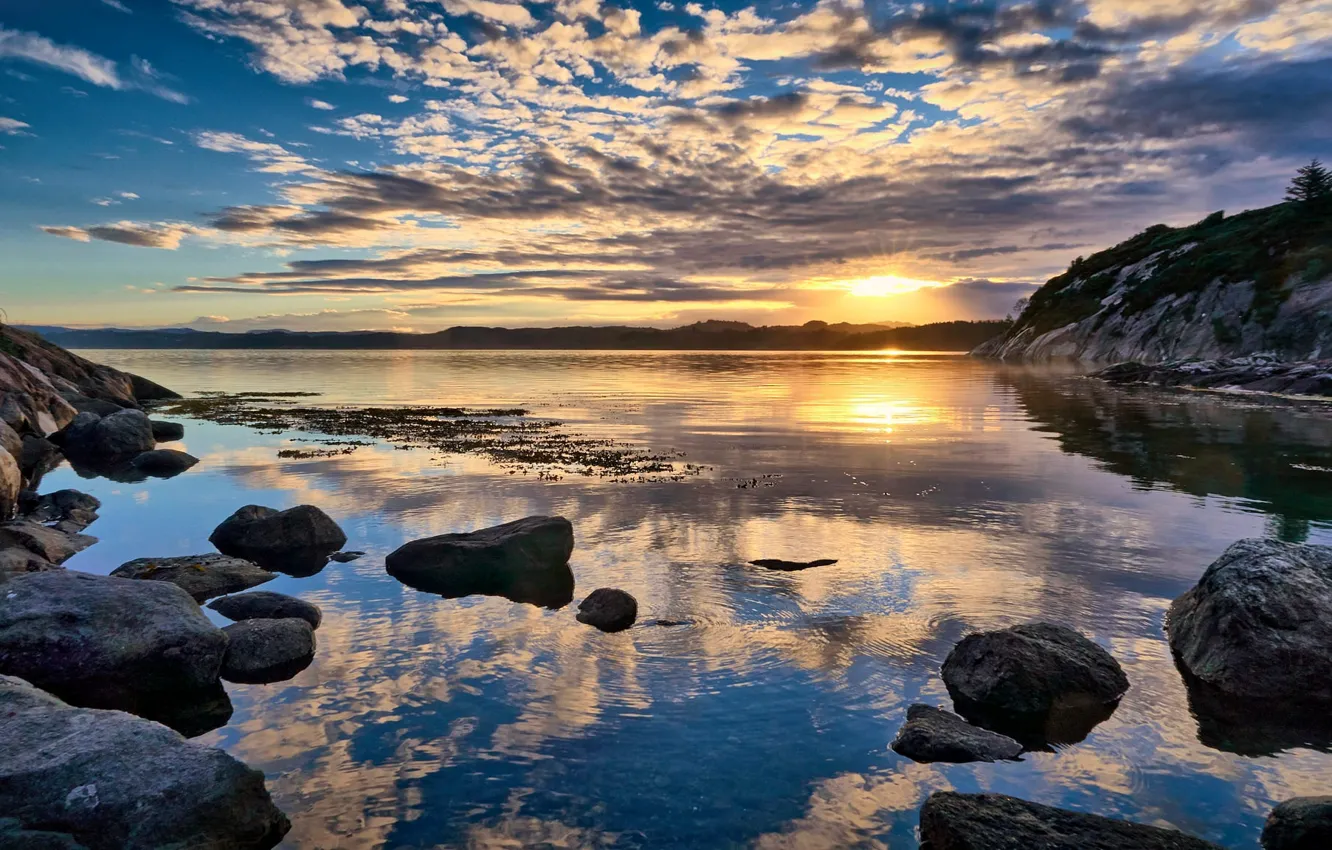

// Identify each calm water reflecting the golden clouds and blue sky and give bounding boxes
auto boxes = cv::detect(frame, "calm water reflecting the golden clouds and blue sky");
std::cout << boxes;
[47,350,1332,850]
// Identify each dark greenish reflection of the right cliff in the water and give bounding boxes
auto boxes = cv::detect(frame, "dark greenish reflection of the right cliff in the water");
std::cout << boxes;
[996,370,1332,542]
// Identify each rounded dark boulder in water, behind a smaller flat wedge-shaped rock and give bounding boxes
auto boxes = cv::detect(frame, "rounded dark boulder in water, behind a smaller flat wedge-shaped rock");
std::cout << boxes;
[942,622,1128,749]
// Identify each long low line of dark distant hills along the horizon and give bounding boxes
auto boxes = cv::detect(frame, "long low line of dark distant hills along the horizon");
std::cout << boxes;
[23,321,1008,352]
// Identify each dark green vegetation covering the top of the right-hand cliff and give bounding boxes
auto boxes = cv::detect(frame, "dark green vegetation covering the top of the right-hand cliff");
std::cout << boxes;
[1014,204,1332,333]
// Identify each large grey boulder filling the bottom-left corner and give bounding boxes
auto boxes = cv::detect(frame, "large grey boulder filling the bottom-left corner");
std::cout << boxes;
[0,677,290,850]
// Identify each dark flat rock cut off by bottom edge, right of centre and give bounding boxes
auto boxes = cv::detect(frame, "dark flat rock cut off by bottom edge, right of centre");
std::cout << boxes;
[920,791,1221,850]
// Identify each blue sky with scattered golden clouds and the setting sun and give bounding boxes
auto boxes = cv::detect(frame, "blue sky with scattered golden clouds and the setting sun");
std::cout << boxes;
[0,0,1332,332]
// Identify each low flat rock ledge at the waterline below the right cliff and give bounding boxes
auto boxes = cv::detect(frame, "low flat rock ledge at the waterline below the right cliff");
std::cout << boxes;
[1092,354,1332,397]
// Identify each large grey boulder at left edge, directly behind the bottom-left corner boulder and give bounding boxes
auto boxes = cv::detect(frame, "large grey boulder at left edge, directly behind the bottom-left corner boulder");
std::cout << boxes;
[0,570,226,723]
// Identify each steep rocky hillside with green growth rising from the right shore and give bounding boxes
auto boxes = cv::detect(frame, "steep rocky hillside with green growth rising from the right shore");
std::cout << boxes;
[974,203,1332,362]
